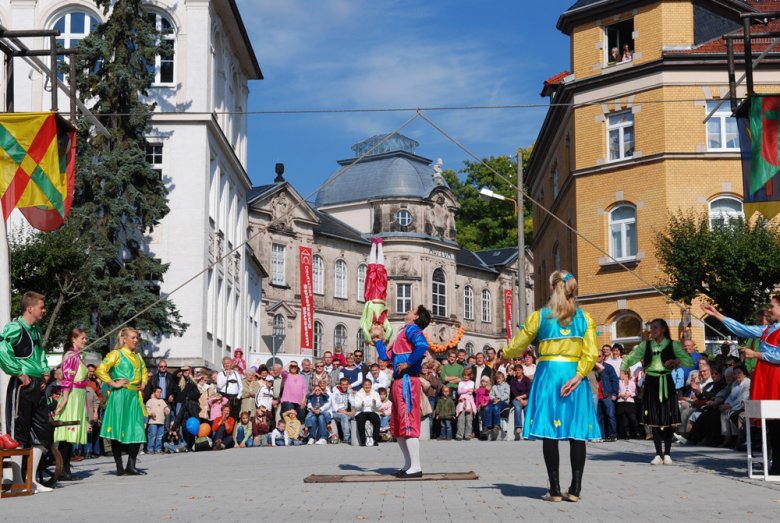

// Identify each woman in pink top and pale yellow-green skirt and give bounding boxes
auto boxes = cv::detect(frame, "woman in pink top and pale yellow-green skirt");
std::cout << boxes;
[53,327,89,481]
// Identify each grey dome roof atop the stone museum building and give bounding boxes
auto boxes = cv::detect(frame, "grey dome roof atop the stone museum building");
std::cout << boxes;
[314,135,448,207]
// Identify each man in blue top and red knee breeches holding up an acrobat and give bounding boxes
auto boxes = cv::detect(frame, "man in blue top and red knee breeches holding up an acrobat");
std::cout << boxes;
[371,305,431,478]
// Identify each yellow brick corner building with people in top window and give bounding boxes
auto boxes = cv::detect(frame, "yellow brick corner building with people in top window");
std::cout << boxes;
[525,0,780,350]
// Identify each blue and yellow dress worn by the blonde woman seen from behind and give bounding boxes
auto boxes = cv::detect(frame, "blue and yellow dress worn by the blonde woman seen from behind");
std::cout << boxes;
[504,307,601,441]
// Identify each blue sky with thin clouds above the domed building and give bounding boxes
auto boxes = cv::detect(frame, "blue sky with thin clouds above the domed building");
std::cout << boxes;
[238,0,573,199]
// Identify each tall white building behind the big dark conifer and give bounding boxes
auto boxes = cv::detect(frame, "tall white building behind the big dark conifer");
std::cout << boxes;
[0,0,264,366]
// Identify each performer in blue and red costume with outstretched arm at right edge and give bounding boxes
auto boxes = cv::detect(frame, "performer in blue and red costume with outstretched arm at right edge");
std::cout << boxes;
[701,294,780,476]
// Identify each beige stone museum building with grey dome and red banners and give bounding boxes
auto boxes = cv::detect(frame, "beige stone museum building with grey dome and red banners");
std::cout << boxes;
[249,135,532,364]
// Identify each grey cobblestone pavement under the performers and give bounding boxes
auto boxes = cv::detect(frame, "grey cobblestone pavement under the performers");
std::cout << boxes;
[0,441,780,523]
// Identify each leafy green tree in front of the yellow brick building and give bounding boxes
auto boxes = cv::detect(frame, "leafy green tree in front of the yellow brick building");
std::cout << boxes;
[655,212,780,320]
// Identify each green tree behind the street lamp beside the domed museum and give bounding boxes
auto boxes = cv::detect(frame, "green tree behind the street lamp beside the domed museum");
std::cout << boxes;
[442,147,533,251]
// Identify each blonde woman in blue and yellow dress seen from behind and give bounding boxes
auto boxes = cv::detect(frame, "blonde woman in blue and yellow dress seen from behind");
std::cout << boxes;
[504,271,601,502]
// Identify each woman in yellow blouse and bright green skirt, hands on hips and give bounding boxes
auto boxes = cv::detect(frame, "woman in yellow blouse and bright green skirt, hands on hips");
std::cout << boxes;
[95,327,148,476]
